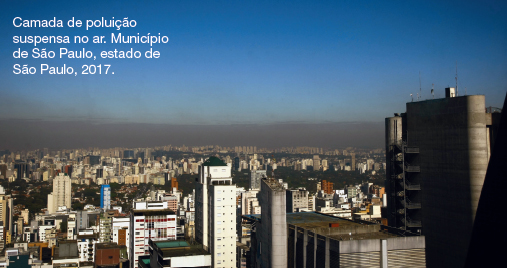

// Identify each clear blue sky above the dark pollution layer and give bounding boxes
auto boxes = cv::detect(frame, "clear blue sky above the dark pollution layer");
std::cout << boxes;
[0,1,507,124]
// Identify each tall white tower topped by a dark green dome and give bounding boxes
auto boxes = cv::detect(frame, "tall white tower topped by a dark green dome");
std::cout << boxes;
[195,156,236,268]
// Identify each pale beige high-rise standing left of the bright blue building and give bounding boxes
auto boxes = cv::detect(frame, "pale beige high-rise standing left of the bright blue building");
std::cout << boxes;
[48,173,71,214]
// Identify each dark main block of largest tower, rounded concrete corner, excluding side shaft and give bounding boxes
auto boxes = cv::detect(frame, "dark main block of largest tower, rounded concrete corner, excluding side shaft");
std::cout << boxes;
[407,95,488,267]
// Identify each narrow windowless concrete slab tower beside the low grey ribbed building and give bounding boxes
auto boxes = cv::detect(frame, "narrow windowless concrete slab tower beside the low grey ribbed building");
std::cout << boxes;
[252,179,287,268]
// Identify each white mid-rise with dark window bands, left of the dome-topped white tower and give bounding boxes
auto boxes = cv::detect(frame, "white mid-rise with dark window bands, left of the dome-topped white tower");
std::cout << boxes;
[129,201,176,268]
